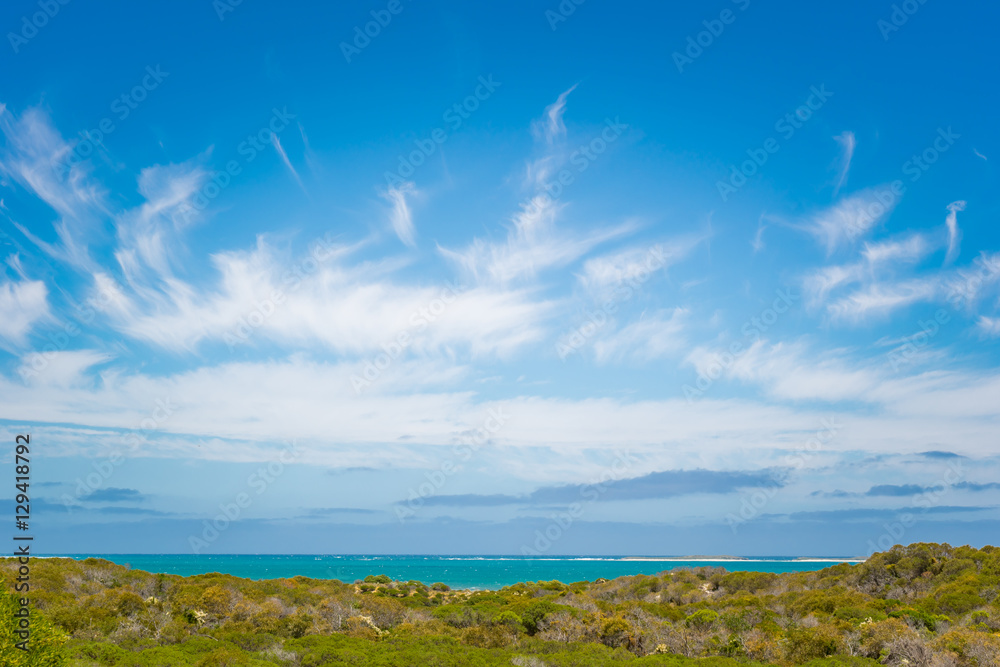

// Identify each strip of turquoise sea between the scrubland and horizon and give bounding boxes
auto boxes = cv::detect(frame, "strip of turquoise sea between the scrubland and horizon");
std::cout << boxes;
[52,554,850,589]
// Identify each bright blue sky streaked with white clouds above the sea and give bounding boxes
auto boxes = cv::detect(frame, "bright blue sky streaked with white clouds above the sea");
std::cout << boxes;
[0,0,1000,556]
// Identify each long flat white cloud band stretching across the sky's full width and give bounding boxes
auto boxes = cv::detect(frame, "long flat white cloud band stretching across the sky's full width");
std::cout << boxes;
[0,352,1000,482]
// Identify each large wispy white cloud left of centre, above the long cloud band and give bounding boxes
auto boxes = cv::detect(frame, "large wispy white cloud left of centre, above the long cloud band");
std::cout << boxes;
[93,238,553,355]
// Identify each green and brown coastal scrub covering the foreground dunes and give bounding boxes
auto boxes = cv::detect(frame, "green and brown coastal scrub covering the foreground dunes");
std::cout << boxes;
[0,544,1000,667]
